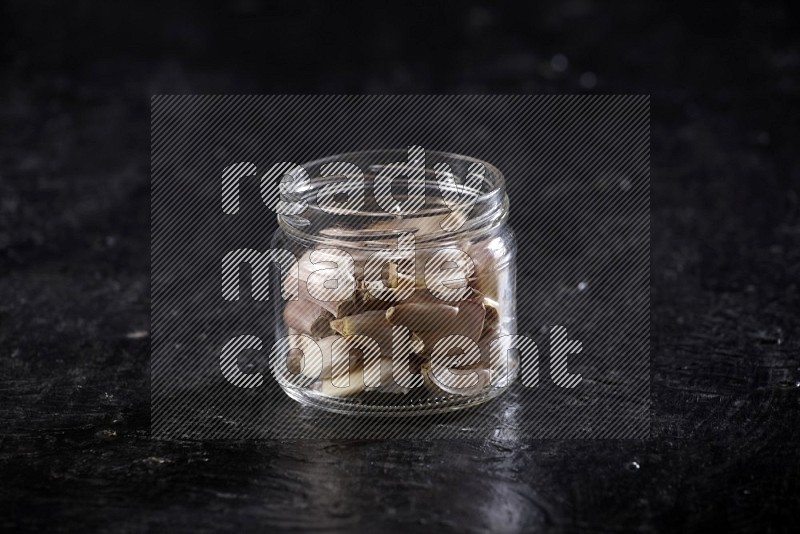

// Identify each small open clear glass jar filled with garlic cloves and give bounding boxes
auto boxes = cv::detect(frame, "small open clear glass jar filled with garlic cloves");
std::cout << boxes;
[270,147,519,415]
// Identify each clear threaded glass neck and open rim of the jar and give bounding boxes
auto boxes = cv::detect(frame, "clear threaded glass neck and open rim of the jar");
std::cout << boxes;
[278,150,508,249]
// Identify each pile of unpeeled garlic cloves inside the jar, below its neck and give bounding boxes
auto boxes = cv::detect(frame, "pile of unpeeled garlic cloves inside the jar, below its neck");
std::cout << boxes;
[283,245,505,397]
